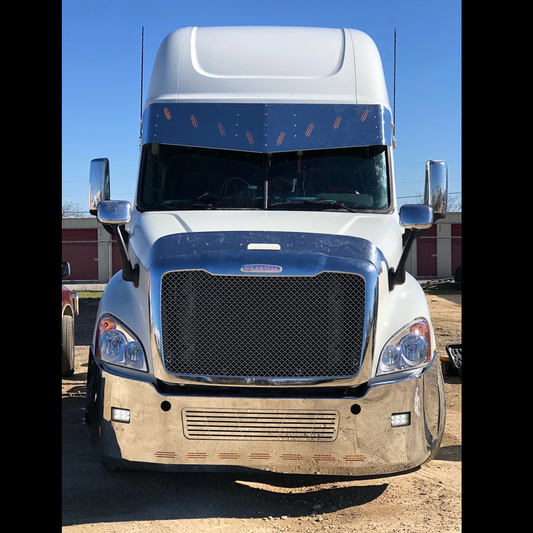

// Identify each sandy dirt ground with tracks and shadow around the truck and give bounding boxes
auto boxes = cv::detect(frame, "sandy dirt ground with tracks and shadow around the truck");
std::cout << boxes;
[62,294,462,533]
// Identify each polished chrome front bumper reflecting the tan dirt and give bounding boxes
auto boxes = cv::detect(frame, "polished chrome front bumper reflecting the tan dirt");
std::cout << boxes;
[86,354,445,477]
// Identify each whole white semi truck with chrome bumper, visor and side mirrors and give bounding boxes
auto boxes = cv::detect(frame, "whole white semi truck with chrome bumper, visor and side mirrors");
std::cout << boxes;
[86,27,447,476]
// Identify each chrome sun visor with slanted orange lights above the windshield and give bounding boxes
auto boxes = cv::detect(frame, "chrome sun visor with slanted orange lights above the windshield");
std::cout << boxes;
[142,103,392,152]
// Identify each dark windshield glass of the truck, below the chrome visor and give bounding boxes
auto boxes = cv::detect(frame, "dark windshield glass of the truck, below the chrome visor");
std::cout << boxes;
[138,144,389,211]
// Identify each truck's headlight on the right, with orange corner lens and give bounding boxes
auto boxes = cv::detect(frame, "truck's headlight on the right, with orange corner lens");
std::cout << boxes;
[377,318,431,375]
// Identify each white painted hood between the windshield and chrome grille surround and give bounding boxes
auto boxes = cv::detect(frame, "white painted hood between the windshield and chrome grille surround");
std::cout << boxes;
[126,210,403,269]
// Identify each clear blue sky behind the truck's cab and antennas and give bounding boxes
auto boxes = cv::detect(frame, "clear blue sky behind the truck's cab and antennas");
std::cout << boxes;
[62,0,462,211]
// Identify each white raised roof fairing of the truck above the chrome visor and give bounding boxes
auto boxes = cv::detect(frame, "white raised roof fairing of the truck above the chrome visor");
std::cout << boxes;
[145,26,390,110]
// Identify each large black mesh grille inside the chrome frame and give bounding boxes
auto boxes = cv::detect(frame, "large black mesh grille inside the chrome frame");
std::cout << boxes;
[161,270,365,378]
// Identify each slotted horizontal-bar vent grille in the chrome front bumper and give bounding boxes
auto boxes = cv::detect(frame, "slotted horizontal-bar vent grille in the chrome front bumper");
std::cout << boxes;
[182,409,339,442]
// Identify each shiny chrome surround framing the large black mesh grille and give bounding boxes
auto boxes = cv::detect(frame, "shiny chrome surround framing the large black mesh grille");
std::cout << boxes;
[147,231,382,387]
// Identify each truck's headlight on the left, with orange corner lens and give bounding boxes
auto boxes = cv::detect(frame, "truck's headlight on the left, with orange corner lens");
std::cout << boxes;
[96,314,148,372]
